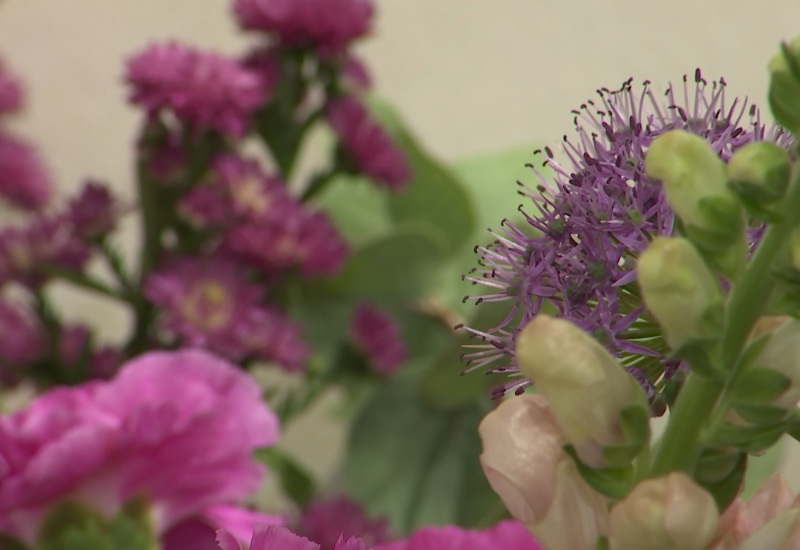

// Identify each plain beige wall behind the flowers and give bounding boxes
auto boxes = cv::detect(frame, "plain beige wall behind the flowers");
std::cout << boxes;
[0,0,800,496]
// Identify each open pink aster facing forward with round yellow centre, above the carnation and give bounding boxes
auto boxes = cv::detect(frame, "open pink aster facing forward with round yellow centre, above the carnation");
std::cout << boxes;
[144,257,263,360]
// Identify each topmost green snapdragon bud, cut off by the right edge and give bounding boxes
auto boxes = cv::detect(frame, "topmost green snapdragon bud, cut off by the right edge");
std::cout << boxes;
[769,36,800,135]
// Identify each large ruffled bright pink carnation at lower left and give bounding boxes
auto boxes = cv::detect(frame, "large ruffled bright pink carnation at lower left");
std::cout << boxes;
[0,350,278,541]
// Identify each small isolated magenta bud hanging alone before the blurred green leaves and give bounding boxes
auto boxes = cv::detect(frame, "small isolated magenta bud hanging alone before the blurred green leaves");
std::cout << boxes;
[350,303,407,376]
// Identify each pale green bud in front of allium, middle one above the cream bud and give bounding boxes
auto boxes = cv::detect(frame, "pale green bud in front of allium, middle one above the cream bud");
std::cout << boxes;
[636,237,722,351]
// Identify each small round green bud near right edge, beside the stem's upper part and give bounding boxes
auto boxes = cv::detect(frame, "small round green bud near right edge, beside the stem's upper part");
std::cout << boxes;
[728,141,792,205]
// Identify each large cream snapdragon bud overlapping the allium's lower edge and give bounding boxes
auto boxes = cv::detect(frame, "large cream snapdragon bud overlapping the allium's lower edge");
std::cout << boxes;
[516,315,648,468]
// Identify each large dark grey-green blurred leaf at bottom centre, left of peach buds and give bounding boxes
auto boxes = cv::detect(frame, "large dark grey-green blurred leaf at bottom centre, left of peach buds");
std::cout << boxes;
[345,377,504,533]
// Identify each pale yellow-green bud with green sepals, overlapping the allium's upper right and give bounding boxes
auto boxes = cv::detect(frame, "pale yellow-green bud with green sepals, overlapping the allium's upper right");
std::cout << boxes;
[645,130,744,252]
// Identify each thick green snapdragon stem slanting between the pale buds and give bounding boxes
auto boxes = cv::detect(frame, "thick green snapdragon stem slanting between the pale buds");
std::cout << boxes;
[651,162,800,476]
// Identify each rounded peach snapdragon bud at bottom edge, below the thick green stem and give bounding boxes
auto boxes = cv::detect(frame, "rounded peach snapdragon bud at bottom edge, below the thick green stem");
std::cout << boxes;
[608,472,719,550]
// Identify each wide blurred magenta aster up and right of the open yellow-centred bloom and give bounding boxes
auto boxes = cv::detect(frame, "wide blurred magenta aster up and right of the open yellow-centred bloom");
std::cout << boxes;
[223,206,348,276]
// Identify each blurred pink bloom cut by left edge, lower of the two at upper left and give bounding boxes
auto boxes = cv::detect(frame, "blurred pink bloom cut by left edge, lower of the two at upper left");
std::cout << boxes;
[0,134,52,210]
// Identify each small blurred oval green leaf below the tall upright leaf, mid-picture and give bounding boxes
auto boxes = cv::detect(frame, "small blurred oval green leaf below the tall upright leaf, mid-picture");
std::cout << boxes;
[330,224,444,300]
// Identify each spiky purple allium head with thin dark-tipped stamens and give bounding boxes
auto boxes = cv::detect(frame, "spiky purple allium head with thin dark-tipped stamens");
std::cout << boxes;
[465,70,790,393]
